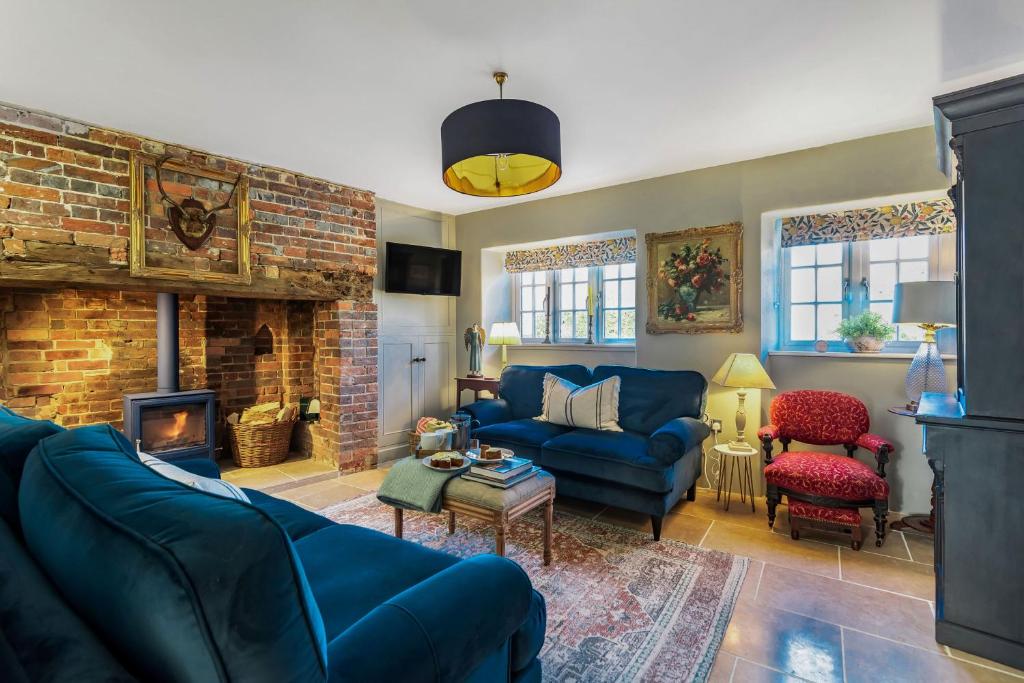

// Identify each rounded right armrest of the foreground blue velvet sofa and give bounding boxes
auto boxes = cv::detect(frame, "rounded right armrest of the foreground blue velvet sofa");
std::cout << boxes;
[328,555,534,683]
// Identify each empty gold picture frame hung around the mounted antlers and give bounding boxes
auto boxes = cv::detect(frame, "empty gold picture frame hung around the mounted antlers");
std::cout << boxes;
[128,152,252,285]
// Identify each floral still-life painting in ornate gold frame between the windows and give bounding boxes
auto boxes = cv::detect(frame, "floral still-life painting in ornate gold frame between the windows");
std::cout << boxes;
[647,223,743,335]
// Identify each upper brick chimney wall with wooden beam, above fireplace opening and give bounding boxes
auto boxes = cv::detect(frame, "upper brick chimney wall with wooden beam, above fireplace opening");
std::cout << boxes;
[0,104,377,301]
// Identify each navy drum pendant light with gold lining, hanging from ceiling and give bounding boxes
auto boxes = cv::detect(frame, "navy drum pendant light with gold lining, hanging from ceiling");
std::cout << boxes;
[441,72,562,197]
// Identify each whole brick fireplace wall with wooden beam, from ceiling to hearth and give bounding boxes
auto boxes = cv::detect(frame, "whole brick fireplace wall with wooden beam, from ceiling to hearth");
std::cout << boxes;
[0,105,377,471]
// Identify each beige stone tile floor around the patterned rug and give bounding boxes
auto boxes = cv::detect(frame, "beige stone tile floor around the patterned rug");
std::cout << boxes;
[221,459,1024,683]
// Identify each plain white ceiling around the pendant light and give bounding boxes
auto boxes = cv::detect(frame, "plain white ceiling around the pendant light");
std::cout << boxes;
[6,0,1024,213]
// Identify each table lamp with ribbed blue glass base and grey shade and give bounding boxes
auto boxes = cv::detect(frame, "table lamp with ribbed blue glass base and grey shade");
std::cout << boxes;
[893,280,956,411]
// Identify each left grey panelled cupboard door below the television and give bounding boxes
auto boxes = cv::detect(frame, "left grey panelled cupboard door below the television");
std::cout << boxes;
[378,336,422,451]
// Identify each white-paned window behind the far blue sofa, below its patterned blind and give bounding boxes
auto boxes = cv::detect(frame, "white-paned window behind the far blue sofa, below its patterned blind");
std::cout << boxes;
[514,263,636,344]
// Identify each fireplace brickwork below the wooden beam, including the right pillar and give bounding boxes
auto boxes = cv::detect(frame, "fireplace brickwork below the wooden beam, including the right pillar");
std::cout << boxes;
[0,289,368,470]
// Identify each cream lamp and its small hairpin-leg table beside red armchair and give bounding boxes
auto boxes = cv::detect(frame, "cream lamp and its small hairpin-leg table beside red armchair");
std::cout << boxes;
[712,353,775,512]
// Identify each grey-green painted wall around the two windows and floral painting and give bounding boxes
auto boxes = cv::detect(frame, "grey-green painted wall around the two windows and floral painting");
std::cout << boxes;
[456,128,954,513]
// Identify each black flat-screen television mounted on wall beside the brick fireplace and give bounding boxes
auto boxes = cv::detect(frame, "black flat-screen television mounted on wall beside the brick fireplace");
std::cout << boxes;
[384,242,462,296]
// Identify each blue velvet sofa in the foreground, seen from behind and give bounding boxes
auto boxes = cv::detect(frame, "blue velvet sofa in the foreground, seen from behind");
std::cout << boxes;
[0,409,546,683]
